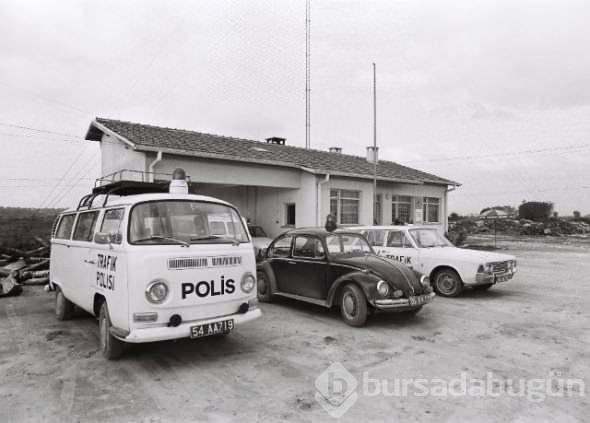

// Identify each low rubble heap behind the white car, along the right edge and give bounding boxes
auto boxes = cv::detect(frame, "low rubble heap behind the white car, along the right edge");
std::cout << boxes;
[449,217,590,242]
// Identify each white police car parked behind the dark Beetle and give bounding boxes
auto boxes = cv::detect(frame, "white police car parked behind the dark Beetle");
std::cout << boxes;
[347,225,516,297]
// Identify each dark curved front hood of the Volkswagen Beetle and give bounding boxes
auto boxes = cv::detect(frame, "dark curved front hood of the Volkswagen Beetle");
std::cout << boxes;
[332,254,426,296]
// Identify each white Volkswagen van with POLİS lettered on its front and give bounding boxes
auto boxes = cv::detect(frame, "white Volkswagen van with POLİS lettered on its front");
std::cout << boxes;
[50,169,261,359]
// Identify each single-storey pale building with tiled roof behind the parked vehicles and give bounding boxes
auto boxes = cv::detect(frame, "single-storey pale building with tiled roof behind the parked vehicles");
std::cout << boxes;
[86,118,459,237]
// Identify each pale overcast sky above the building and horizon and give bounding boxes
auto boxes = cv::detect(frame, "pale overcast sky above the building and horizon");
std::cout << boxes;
[0,0,590,215]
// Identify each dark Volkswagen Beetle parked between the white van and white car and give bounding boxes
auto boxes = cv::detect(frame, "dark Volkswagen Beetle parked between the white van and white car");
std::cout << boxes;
[258,228,434,326]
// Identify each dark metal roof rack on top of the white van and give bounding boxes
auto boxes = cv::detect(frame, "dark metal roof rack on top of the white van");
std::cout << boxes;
[76,169,190,210]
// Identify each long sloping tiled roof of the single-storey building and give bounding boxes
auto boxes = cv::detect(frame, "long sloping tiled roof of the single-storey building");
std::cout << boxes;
[86,118,459,185]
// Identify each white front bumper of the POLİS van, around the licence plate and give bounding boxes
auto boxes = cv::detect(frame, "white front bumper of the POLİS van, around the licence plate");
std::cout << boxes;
[117,308,262,344]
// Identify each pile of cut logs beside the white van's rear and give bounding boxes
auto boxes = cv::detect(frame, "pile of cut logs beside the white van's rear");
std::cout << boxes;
[0,237,49,297]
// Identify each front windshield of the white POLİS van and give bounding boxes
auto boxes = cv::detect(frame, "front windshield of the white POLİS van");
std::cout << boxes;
[129,200,249,245]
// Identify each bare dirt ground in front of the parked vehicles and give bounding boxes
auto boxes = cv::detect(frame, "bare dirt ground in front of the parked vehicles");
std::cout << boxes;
[0,240,590,422]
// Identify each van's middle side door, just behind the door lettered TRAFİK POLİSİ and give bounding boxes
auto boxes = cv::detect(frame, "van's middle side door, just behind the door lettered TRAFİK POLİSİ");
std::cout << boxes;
[69,210,100,313]
